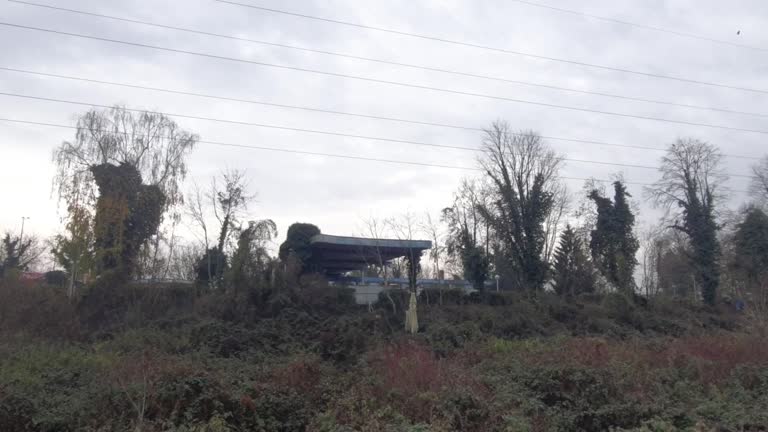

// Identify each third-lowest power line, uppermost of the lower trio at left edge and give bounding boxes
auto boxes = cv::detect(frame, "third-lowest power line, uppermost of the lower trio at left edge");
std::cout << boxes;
[0,66,761,160]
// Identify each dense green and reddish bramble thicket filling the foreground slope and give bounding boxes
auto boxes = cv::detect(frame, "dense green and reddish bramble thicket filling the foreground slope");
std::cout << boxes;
[0,284,768,432]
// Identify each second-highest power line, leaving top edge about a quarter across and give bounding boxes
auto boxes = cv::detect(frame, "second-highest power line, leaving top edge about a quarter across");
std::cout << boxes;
[214,0,768,93]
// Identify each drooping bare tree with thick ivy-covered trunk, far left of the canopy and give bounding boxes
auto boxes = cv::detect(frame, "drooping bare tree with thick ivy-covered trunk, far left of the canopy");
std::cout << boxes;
[54,106,198,280]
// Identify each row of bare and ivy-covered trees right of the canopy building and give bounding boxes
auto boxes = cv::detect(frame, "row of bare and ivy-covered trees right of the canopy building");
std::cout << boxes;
[443,122,768,313]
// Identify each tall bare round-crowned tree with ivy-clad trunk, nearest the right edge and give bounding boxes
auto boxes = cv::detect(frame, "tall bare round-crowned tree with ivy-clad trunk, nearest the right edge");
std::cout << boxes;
[646,138,727,305]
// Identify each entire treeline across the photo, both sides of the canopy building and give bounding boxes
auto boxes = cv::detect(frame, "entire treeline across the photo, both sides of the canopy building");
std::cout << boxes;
[0,107,768,318]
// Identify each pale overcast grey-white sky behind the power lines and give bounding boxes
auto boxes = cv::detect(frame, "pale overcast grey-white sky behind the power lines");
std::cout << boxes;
[0,0,768,246]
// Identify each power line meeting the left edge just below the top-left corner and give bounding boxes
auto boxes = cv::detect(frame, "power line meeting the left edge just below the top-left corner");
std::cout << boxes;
[0,22,768,134]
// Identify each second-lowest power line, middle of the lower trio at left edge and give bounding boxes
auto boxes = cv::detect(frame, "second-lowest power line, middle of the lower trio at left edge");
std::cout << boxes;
[0,92,754,178]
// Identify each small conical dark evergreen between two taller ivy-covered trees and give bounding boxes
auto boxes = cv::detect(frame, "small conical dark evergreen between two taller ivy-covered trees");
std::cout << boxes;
[552,225,597,296]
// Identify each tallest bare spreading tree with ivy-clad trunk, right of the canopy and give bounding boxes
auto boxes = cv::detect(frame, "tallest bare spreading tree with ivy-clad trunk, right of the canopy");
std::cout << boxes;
[480,122,562,290]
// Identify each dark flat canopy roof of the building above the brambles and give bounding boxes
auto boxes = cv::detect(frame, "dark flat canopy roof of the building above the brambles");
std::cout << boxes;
[309,234,432,275]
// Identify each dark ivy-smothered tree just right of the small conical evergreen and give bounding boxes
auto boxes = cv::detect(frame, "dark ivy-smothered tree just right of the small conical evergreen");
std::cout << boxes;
[589,181,640,295]
